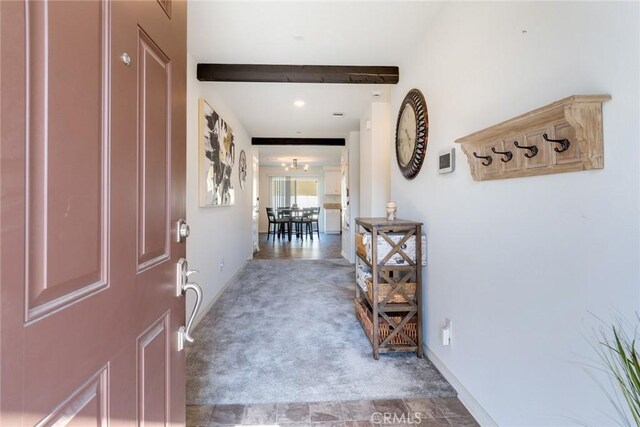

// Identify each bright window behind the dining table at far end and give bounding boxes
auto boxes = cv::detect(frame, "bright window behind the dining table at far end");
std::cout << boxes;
[271,176,319,208]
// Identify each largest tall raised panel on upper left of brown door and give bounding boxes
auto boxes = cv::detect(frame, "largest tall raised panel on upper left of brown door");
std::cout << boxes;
[25,2,109,321]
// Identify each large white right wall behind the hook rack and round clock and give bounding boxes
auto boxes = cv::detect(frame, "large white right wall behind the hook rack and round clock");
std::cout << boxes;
[391,2,640,426]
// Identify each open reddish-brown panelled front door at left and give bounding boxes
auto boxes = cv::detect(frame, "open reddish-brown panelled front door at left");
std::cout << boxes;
[0,0,186,426]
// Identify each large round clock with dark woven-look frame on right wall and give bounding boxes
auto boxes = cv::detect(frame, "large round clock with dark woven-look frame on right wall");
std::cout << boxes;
[396,89,429,179]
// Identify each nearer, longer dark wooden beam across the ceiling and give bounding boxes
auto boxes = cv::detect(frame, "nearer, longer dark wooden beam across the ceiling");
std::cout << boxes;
[197,64,400,84]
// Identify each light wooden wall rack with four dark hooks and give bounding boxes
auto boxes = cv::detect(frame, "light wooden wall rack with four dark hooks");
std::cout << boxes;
[456,95,611,181]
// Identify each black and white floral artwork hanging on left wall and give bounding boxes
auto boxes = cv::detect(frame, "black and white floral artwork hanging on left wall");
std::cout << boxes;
[198,99,235,207]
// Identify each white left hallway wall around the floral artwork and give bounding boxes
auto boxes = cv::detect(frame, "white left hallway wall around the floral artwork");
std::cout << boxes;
[187,55,253,324]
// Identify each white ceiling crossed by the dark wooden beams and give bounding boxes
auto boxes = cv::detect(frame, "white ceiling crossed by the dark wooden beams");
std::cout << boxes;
[188,0,440,165]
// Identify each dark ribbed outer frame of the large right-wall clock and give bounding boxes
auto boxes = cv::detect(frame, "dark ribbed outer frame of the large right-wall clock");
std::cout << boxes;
[396,89,429,179]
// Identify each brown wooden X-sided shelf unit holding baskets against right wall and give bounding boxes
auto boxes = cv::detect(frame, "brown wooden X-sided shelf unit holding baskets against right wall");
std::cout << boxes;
[354,217,423,360]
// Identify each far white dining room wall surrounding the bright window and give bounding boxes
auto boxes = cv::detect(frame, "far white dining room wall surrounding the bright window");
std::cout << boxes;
[258,166,328,233]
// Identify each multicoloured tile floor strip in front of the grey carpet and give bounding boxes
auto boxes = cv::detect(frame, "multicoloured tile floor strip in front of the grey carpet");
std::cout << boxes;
[187,397,479,427]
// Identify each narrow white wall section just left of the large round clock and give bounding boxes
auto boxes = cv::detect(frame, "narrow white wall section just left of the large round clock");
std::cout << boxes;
[360,102,393,217]
